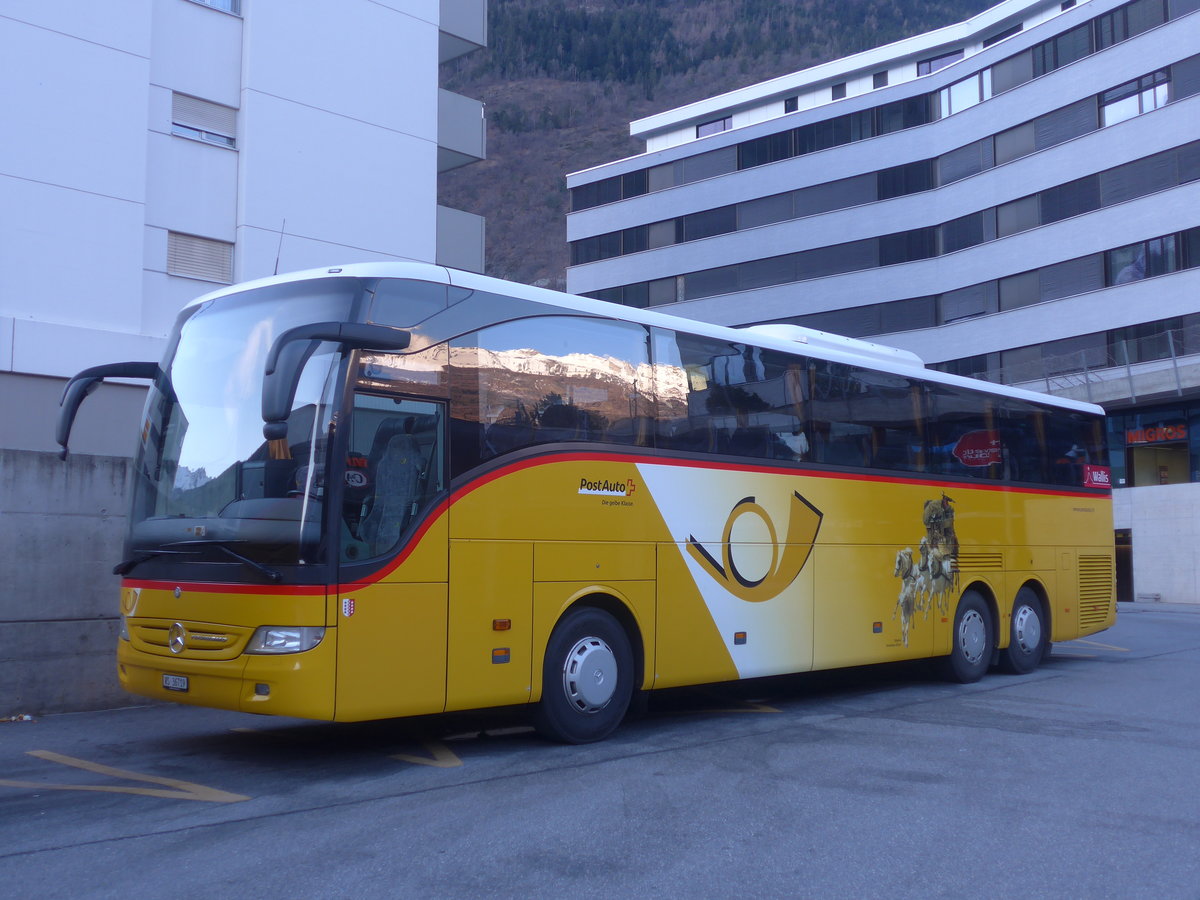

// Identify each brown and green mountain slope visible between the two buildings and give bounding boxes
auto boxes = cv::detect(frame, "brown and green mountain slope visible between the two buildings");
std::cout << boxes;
[439,0,990,288]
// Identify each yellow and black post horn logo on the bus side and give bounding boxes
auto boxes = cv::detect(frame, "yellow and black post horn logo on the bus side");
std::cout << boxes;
[688,491,822,604]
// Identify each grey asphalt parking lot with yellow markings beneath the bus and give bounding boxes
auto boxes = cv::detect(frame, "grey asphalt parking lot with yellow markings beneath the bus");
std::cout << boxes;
[0,604,1200,898]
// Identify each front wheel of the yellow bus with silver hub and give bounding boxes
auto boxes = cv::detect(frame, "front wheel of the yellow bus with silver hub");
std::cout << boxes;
[534,607,634,744]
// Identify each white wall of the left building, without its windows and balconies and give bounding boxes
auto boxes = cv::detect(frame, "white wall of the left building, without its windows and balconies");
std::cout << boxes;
[0,0,463,450]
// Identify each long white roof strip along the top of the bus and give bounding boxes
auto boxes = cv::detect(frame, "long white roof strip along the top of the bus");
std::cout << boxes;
[185,262,1104,415]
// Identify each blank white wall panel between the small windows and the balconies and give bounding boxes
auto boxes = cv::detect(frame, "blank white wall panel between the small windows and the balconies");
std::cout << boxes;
[236,0,438,280]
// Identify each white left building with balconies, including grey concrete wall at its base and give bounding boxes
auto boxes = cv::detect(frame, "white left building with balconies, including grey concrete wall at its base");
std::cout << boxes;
[0,0,486,715]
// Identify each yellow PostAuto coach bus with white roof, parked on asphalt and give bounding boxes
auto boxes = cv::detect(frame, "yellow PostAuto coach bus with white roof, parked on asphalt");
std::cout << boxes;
[59,263,1116,743]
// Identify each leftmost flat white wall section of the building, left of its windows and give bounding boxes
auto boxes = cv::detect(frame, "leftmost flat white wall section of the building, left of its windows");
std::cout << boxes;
[0,0,151,374]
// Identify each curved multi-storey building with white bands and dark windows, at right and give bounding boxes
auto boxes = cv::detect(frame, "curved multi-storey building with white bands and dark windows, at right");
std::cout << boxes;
[568,0,1200,602]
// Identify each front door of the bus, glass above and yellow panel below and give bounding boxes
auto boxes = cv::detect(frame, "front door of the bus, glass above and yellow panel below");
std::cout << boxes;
[329,392,449,721]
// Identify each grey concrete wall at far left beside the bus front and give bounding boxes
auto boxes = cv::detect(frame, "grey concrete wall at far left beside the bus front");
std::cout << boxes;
[0,449,131,716]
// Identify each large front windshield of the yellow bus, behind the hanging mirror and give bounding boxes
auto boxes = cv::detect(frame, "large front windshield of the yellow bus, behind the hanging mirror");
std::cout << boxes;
[128,278,359,578]
